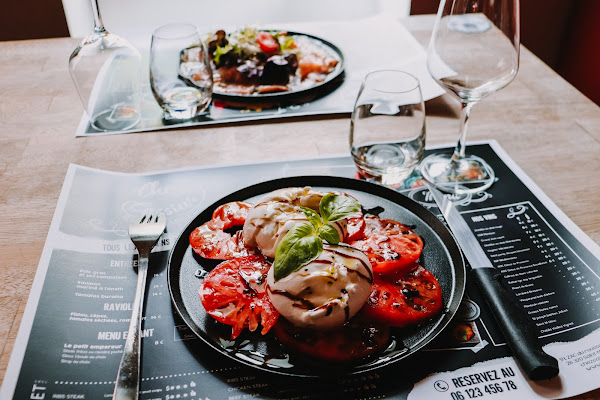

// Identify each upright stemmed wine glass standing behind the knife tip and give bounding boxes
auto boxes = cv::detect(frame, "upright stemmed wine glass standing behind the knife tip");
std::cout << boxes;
[420,0,520,194]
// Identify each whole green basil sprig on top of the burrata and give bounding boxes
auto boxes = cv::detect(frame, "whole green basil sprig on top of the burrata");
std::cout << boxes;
[273,193,360,281]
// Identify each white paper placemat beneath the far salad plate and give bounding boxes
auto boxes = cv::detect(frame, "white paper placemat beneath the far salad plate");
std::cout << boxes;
[76,15,444,136]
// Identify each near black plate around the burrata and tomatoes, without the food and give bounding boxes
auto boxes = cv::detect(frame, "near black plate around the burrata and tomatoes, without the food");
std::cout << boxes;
[168,176,465,377]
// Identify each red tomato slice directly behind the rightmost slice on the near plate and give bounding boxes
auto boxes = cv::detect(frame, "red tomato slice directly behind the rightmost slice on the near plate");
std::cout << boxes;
[349,231,423,274]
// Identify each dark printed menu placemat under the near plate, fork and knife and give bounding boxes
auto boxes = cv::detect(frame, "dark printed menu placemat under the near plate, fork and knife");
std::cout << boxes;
[0,142,600,400]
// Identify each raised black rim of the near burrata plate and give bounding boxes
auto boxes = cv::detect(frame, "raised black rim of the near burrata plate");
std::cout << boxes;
[167,175,467,378]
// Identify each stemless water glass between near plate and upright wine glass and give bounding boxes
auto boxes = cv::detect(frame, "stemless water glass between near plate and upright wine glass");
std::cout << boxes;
[350,70,425,188]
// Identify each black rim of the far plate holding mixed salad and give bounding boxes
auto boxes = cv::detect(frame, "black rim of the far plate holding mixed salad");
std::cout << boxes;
[213,28,346,102]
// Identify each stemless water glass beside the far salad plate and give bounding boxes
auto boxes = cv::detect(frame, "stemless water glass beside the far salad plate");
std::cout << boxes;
[150,23,213,120]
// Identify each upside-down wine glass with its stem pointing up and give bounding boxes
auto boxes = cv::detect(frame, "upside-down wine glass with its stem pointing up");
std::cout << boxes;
[69,0,142,131]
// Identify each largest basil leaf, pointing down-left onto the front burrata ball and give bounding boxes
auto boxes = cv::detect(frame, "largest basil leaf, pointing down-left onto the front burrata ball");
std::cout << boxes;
[273,223,323,281]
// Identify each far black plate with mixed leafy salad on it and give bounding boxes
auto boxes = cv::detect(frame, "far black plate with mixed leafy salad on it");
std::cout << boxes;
[200,27,344,106]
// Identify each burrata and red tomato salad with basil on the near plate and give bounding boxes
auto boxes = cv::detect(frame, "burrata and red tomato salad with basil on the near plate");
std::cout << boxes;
[189,187,443,362]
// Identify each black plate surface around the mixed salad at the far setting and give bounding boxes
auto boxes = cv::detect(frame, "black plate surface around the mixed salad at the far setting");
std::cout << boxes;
[213,29,344,106]
